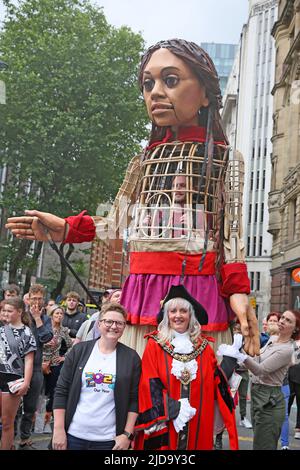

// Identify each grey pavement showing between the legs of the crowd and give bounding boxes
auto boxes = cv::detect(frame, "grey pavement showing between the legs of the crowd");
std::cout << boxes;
[17,401,300,450]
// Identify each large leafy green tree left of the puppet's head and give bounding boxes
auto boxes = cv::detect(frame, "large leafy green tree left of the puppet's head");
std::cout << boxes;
[0,0,147,280]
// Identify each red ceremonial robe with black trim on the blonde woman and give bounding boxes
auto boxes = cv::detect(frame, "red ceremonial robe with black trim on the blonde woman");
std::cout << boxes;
[134,332,238,450]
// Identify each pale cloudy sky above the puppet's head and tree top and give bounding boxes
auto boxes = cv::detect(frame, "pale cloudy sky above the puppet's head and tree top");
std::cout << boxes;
[0,0,249,46]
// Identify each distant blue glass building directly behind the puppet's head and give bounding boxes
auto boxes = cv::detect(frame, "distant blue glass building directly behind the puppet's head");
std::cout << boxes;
[201,42,237,95]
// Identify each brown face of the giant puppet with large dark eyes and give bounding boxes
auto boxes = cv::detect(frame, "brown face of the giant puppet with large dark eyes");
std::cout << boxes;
[143,48,209,130]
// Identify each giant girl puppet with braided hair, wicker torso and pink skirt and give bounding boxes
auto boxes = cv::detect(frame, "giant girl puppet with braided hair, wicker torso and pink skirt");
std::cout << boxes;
[6,39,259,355]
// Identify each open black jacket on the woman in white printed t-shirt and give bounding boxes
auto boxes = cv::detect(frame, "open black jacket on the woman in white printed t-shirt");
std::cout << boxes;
[53,339,141,435]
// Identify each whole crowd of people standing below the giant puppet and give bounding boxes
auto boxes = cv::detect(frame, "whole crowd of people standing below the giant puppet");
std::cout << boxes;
[0,284,300,450]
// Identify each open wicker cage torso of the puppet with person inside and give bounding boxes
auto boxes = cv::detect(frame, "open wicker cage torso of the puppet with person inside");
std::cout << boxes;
[132,142,228,251]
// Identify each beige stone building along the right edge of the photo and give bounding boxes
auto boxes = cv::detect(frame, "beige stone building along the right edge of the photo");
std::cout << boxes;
[269,0,300,312]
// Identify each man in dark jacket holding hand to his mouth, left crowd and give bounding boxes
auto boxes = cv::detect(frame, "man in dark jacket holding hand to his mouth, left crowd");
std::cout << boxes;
[19,284,53,450]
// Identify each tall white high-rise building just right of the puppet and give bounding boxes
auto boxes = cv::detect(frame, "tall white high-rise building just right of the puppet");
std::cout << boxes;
[222,0,278,321]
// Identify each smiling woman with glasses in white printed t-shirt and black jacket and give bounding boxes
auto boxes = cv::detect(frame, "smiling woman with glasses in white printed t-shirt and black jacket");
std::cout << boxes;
[52,303,141,450]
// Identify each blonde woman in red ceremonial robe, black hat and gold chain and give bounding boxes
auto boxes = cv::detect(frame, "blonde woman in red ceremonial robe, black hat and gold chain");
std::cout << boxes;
[135,285,238,451]
